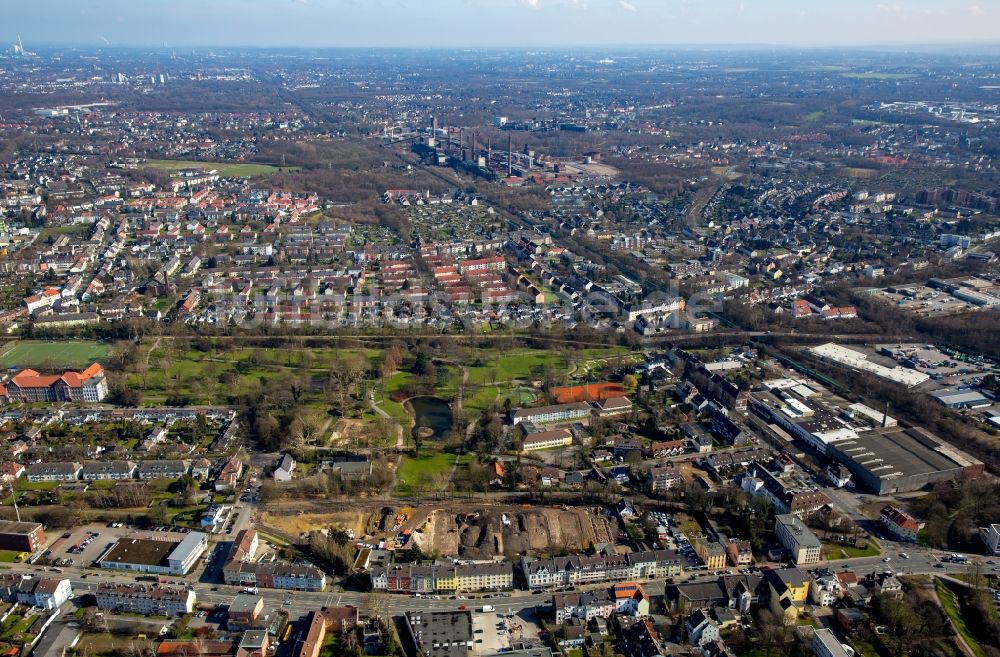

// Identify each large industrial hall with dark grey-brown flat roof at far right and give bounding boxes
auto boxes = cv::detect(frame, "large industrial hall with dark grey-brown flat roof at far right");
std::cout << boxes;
[827,427,983,495]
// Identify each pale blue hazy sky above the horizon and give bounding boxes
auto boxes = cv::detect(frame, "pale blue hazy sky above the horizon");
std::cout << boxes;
[7,0,1000,48]
